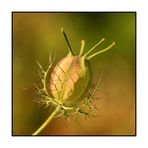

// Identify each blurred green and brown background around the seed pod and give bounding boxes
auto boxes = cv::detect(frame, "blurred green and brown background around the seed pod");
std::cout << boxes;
[12,13,135,135]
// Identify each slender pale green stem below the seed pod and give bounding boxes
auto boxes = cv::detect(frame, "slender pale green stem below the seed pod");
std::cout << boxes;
[32,105,61,136]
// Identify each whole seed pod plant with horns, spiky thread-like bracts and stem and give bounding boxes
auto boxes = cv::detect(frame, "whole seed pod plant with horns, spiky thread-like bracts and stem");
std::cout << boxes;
[33,28,115,135]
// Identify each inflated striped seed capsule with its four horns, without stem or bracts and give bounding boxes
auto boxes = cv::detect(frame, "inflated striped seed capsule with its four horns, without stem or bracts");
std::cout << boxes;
[50,29,115,107]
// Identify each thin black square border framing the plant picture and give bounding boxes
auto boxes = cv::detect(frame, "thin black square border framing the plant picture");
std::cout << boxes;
[11,11,137,137]
